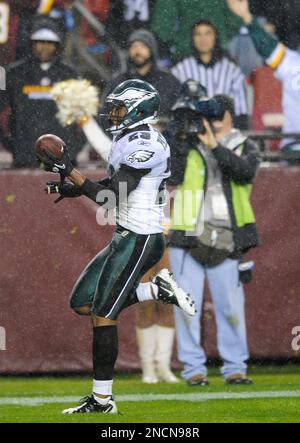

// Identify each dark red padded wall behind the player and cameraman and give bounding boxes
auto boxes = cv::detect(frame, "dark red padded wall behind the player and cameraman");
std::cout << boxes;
[0,166,300,373]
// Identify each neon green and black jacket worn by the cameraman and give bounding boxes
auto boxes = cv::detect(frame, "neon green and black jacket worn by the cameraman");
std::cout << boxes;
[170,140,259,253]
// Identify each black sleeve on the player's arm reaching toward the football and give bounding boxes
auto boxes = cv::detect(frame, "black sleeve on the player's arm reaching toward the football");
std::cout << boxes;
[80,165,150,209]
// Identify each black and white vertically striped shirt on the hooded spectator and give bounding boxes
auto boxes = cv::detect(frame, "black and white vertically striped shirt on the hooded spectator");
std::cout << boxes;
[171,56,248,116]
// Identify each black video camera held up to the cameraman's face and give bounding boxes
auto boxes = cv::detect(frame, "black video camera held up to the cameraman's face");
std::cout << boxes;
[171,80,224,136]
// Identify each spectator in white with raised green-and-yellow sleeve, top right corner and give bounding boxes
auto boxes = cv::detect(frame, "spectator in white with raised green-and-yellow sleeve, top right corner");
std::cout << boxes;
[228,0,300,155]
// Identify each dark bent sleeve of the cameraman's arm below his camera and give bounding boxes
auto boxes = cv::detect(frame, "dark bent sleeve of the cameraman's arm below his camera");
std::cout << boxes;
[213,140,260,184]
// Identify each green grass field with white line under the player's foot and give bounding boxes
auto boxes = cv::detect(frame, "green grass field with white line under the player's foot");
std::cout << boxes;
[0,365,300,423]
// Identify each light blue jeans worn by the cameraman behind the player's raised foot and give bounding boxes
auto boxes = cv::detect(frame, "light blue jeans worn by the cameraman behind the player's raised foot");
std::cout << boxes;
[170,247,249,379]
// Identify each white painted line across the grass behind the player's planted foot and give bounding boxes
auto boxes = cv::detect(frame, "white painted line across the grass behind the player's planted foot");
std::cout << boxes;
[0,390,300,406]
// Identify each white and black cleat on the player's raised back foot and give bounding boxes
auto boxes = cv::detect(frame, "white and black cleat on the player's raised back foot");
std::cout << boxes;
[152,269,196,316]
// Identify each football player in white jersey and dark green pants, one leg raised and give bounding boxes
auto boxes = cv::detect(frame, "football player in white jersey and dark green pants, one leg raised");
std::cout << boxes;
[39,79,195,414]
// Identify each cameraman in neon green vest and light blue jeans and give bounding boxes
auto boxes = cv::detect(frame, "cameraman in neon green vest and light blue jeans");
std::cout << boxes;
[170,86,260,385]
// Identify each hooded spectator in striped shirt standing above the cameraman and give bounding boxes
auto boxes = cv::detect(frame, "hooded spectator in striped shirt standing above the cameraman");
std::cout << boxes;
[172,20,248,129]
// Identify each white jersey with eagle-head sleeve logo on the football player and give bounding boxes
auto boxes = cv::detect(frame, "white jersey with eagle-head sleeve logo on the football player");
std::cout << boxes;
[108,125,170,235]
